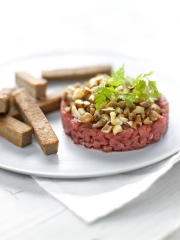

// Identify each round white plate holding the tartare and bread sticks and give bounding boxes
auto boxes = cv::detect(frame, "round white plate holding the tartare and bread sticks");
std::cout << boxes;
[0,52,180,178]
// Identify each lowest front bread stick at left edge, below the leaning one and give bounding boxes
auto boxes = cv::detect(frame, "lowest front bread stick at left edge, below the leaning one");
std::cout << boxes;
[0,115,33,147]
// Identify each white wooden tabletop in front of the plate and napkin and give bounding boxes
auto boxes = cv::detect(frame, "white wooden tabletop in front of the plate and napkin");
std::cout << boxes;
[0,161,180,240]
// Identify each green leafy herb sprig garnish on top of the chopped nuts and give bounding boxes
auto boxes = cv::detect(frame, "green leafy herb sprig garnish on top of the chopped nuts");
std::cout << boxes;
[91,65,161,110]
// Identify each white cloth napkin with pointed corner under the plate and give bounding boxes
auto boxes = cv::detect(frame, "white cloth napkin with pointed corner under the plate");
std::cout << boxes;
[33,152,180,223]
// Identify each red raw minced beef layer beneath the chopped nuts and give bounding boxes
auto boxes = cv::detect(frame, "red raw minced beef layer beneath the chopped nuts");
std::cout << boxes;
[61,96,169,152]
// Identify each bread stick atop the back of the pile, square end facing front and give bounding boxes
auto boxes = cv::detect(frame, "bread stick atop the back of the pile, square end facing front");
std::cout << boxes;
[16,72,47,99]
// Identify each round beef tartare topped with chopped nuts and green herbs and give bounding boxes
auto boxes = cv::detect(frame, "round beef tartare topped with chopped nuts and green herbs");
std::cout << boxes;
[61,67,169,152]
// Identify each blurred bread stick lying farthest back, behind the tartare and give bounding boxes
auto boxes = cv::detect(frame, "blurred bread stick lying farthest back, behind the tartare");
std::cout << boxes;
[42,65,112,81]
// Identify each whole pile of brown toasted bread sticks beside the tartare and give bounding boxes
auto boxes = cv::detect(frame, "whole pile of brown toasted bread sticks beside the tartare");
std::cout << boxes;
[0,65,111,155]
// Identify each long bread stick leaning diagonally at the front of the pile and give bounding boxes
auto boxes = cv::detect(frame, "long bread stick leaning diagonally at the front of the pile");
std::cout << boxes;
[13,88,59,155]
